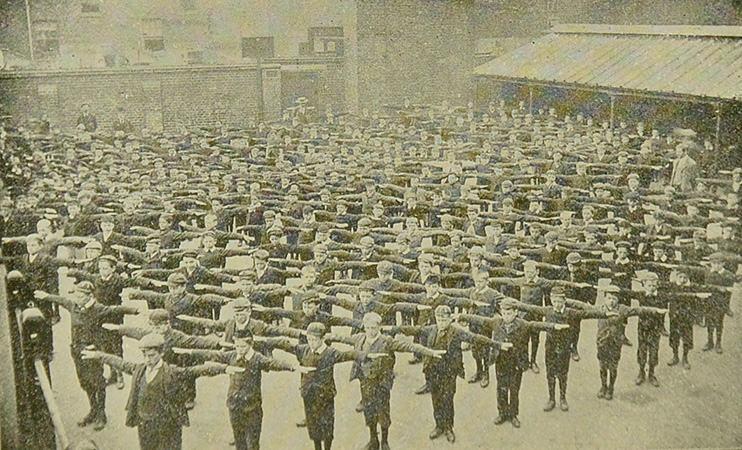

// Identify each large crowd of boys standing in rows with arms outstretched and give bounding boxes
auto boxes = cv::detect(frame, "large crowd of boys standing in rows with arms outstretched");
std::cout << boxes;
[0,101,742,450]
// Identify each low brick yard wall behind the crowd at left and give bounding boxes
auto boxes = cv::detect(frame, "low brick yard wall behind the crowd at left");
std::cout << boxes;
[0,66,280,130]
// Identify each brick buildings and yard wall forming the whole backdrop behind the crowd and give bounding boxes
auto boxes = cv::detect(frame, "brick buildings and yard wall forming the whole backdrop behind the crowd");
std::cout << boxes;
[0,0,742,129]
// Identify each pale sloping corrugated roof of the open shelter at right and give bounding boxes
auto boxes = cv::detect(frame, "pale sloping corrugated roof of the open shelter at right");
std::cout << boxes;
[474,30,742,99]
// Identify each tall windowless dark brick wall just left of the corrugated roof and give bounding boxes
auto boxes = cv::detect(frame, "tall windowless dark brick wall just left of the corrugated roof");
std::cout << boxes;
[358,0,475,110]
